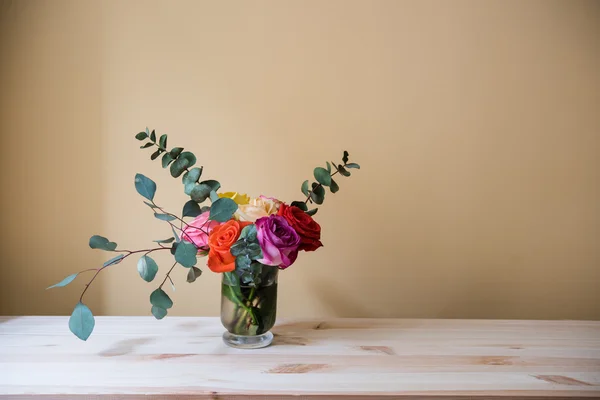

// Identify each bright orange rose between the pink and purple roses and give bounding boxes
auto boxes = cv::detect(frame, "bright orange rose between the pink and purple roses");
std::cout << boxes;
[207,219,252,272]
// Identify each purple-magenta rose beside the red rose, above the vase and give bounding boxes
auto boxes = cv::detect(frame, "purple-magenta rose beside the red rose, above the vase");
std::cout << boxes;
[255,215,300,269]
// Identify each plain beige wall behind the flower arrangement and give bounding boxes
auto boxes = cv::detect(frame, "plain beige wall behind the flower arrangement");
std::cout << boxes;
[0,0,600,319]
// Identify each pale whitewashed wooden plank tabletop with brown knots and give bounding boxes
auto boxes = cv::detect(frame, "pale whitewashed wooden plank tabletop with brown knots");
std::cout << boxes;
[0,317,600,400]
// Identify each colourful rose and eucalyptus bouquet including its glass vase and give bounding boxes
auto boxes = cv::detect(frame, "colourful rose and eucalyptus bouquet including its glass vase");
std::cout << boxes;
[50,129,360,347]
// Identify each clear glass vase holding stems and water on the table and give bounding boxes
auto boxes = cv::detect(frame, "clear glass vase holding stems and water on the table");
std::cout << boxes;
[221,265,279,349]
